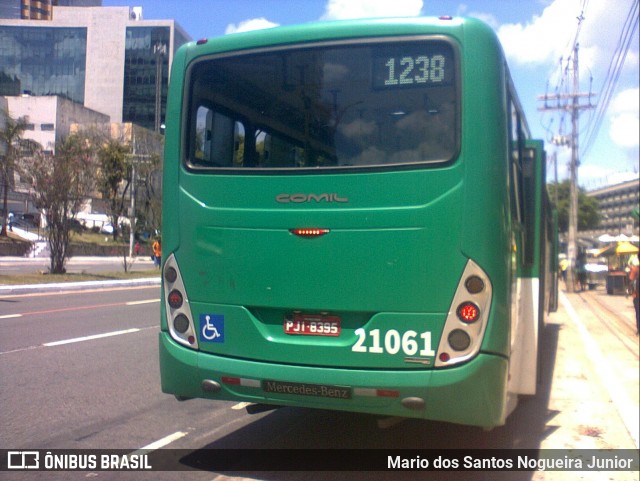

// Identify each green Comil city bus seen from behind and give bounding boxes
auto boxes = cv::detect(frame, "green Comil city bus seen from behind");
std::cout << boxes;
[160,17,555,427]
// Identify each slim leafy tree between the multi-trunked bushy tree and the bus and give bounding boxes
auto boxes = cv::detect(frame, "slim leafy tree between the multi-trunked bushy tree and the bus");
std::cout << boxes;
[98,139,133,241]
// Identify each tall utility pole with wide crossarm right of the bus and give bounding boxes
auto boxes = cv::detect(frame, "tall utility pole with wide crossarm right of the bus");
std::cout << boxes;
[538,42,594,292]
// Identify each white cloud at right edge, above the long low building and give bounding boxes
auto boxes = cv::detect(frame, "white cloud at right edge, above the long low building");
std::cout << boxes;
[609,88,640,147]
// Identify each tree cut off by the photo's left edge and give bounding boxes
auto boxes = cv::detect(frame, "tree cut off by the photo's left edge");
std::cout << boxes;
[0,109,29,237]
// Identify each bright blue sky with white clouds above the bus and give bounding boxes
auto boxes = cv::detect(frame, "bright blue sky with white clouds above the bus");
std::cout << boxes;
[103,0,640,190]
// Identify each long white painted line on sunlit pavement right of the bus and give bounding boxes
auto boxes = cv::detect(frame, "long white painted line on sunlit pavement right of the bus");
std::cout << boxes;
[560,292,640,448]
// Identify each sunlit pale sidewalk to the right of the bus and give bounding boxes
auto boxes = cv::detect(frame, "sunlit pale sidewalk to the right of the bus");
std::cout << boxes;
[544,283,640,458]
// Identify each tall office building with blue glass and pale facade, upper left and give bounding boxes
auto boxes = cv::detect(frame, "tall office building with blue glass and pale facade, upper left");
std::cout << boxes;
[0,2,190,130]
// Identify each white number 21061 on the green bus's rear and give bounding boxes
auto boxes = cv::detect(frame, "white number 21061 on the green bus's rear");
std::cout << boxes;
[351,328,436,356]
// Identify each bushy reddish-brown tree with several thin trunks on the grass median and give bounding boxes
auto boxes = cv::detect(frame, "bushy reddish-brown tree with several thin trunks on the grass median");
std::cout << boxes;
[23,134,95,274]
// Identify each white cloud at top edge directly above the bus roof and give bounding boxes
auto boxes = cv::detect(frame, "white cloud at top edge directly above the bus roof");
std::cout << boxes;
[322,0,423,20]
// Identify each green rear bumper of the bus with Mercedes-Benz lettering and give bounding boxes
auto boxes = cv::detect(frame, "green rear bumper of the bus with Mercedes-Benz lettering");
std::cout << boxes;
[159,331,508,427]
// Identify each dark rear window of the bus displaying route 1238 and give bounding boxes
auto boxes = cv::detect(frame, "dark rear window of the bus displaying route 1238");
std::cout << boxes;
[185,40,459,170]
